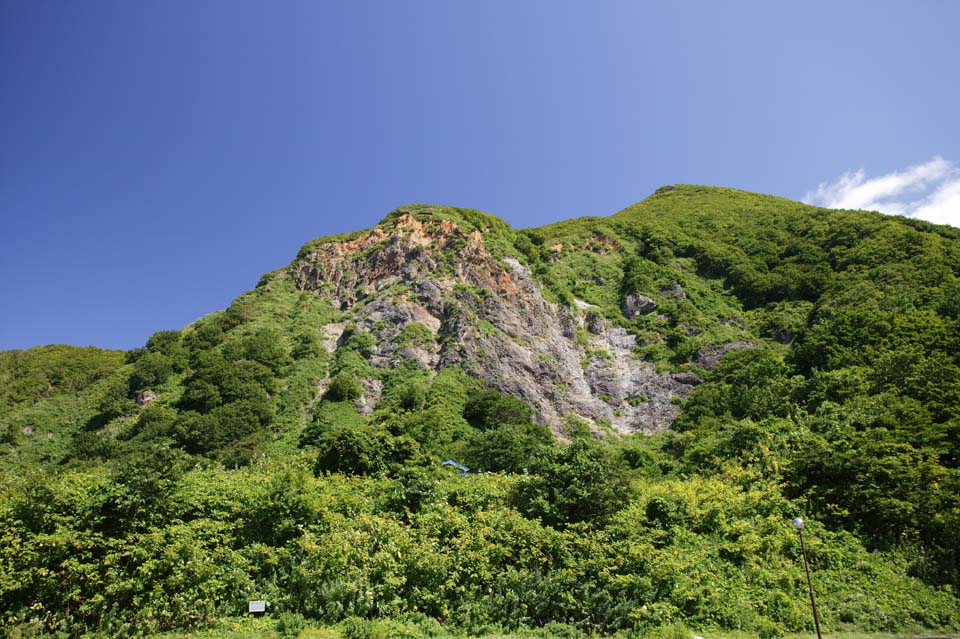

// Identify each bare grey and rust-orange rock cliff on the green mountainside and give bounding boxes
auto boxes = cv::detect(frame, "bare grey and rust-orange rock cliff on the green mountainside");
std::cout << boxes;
[291,213,699,434]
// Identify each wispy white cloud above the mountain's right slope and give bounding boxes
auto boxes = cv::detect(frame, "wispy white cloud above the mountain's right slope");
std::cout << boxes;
[803,157,960,227]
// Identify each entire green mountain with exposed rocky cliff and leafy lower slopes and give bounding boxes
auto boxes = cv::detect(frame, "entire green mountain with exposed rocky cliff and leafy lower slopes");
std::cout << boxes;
[0,186,960,637]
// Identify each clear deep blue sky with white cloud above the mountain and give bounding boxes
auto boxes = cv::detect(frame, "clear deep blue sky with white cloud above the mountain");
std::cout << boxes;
[0,0,960,349]
